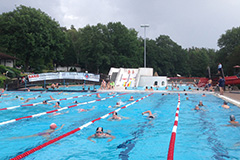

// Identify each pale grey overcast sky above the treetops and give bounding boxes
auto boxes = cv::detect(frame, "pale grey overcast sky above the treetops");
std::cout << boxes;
[0,0,240,49]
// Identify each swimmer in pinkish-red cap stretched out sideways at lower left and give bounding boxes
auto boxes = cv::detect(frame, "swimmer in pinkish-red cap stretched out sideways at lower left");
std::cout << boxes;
[12,123,64,139]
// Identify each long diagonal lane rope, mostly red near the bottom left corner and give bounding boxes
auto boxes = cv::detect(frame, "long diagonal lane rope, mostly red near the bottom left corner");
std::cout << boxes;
[11,93,153,160]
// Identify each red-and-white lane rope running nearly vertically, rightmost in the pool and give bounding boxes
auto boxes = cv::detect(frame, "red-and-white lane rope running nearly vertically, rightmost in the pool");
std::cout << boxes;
[167,93,180,160]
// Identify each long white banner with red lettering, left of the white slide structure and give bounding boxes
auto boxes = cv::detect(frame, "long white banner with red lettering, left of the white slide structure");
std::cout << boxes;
[28,72,100,82]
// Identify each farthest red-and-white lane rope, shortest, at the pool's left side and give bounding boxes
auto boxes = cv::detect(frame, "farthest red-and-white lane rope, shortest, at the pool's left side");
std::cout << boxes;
[0,93,99,111]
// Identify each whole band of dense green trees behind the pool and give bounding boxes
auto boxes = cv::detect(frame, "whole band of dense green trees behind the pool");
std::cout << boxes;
[0,6,240,76]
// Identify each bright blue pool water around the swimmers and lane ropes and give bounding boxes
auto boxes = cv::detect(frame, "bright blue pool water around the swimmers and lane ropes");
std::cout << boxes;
[0,92,240,160]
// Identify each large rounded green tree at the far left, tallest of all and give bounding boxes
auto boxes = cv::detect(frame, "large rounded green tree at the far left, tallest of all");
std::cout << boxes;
[0,5,66,71]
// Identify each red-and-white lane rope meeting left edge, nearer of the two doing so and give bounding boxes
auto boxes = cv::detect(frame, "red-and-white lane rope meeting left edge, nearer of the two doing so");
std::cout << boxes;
[0,93,127,126]
